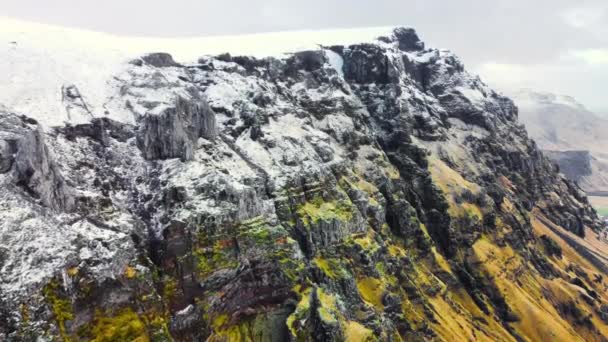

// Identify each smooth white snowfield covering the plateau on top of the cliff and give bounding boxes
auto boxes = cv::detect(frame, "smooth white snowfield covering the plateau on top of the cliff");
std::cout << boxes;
[0,17,424,126]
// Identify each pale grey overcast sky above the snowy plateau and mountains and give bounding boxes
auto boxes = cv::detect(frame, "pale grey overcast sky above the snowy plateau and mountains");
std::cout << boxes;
[0,0,608,113]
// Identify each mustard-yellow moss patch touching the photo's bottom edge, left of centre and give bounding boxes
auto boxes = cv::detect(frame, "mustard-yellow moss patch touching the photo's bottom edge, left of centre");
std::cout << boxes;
[91,308,150,342]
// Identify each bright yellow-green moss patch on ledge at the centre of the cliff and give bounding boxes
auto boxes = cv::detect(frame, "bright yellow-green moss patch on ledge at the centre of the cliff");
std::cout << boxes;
[296,196,353,225]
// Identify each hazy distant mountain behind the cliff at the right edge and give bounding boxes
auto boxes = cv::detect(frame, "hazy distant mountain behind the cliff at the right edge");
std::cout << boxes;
[514,90,608,193]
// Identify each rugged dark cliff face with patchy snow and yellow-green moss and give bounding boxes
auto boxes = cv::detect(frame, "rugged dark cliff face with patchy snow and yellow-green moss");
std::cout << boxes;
[0,29,608,341]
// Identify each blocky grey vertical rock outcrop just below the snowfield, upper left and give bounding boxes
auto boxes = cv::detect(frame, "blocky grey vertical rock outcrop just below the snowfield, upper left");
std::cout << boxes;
[137,98,217,160]
